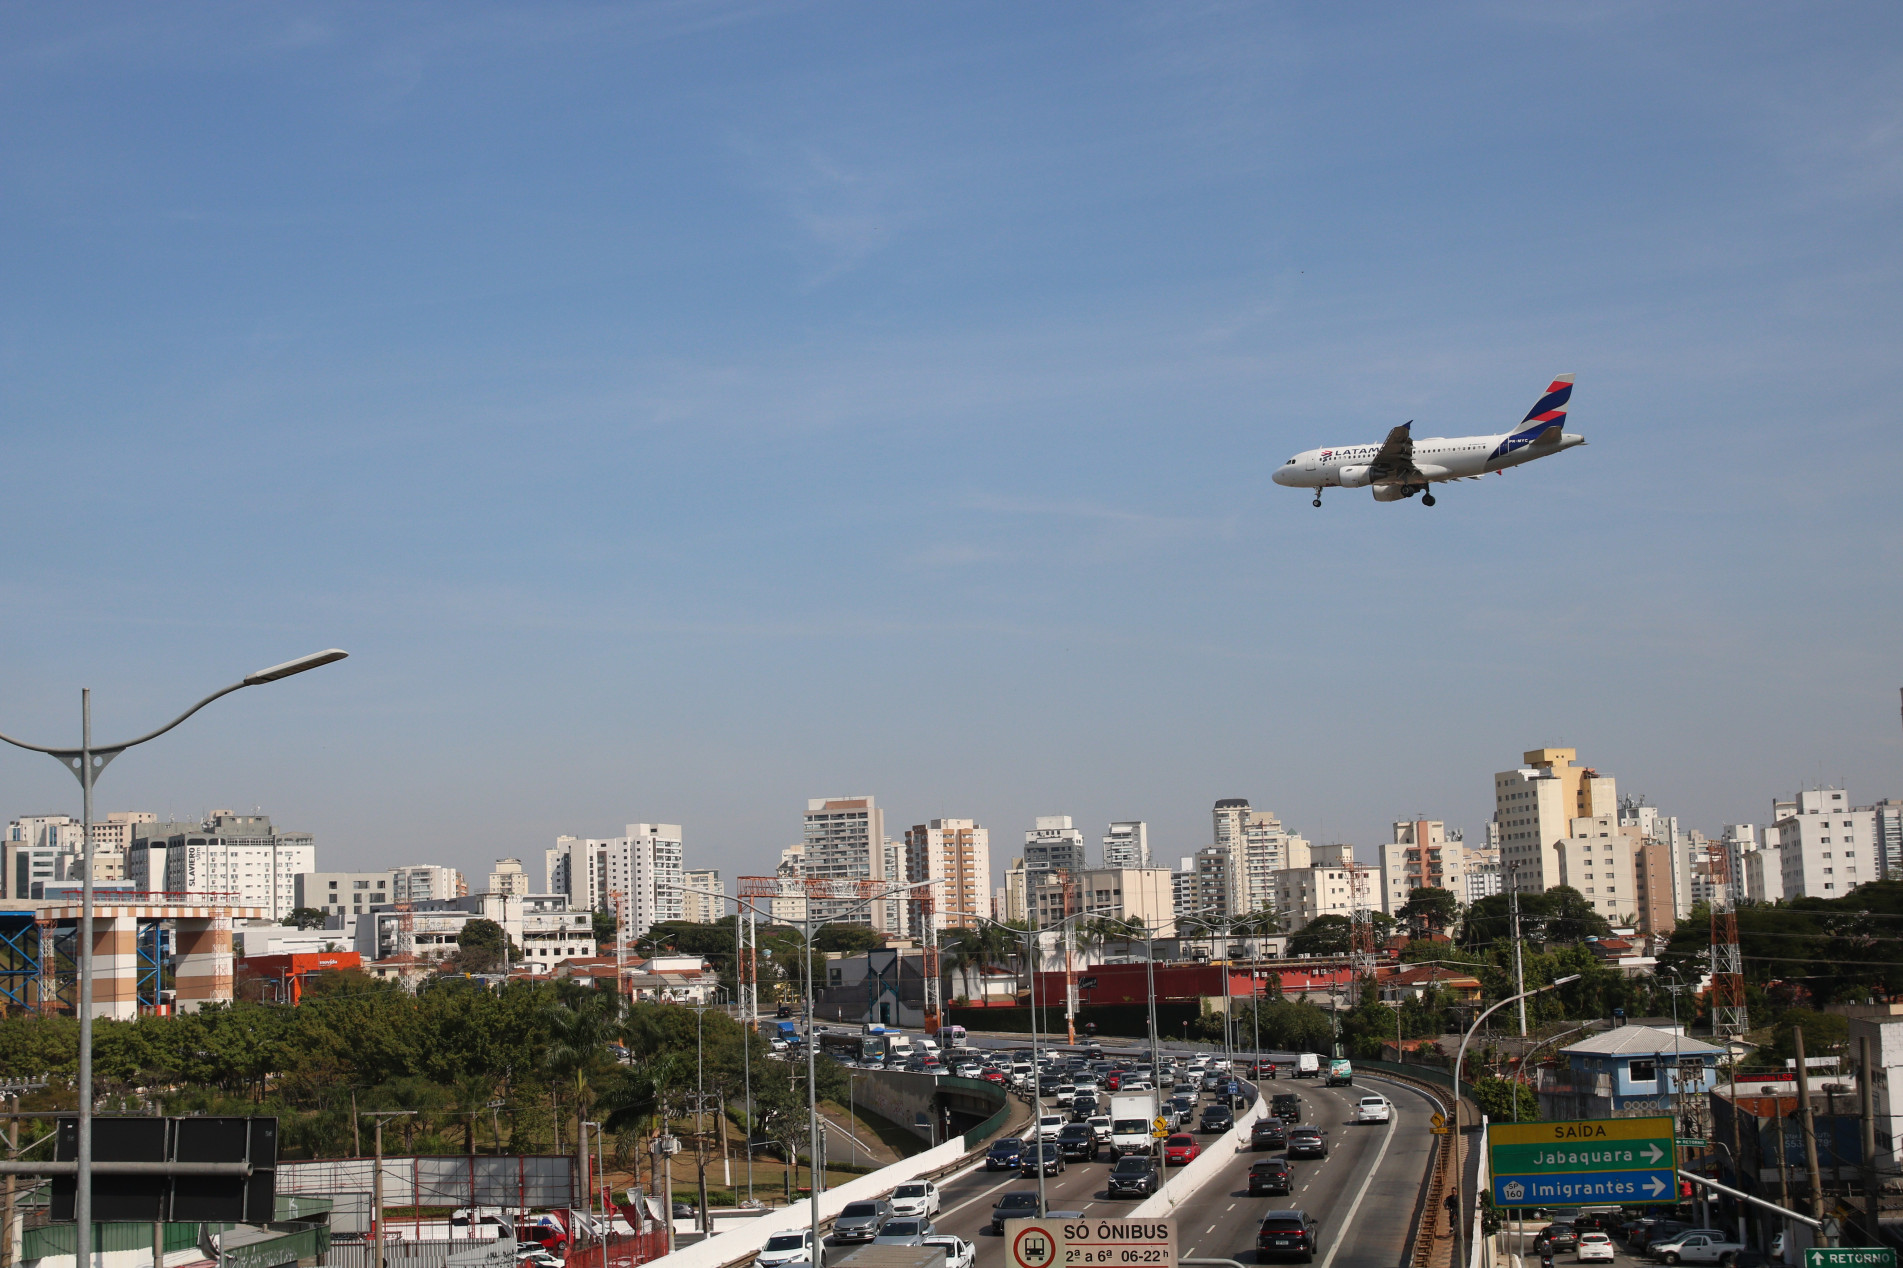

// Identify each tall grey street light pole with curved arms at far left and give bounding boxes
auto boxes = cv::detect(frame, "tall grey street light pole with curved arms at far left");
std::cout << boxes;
[0,647,350,1268]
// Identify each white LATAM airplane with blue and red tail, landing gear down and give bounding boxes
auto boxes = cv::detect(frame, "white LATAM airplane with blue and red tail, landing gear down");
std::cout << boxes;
[1275,375,1585,506]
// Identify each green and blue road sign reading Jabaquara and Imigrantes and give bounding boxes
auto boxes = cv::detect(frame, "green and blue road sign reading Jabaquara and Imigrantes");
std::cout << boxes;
[1486,1118,1678,1207]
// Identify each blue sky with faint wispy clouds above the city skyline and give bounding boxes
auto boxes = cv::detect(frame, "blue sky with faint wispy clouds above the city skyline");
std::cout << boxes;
[0,2,1903,887]
